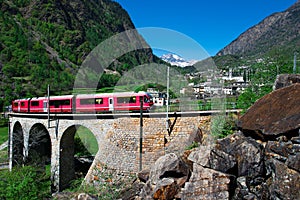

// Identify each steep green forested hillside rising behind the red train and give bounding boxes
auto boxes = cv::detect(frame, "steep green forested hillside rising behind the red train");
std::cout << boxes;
[0,0,155,107]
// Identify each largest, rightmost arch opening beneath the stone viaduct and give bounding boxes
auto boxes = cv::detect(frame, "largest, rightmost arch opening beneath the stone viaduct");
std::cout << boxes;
[59,125,98,190]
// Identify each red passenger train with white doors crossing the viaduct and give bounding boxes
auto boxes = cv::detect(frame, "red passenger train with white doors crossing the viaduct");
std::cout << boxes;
[12,92,153,113]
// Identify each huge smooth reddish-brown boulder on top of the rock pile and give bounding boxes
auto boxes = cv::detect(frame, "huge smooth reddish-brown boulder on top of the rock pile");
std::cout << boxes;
[238,83,300,140]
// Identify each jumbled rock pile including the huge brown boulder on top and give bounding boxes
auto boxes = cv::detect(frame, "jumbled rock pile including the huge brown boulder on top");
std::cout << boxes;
[136,81,300,200]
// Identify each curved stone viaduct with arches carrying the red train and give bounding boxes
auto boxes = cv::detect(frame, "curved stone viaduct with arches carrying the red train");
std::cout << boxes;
[9,112,223,191]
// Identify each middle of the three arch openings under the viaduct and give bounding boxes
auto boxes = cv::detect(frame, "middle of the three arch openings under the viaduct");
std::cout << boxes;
[26,123,51,166]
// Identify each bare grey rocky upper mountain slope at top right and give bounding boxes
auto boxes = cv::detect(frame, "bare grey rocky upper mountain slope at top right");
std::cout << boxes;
[217,0,300,57]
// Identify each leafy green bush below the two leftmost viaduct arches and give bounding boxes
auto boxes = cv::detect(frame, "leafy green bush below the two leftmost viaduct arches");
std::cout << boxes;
[0,166,51,200]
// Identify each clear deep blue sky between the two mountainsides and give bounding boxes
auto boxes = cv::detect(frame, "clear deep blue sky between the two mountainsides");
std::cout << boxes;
[115,0,297,59]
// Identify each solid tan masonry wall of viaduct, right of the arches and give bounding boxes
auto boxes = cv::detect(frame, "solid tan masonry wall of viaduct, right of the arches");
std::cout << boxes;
[86,116,210,182]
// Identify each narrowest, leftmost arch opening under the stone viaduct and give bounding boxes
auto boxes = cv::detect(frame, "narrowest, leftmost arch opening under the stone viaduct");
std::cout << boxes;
[12,121,24,166]
